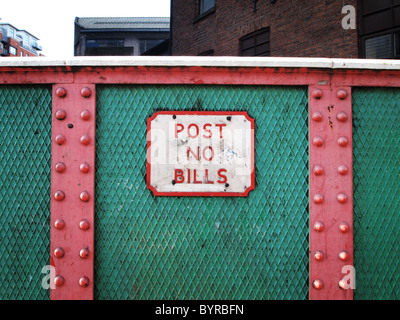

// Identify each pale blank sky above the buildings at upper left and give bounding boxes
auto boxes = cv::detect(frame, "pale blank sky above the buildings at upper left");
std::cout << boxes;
[0,0,170,58]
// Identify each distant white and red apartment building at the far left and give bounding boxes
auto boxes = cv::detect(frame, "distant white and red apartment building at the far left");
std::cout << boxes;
[0,23,42,57]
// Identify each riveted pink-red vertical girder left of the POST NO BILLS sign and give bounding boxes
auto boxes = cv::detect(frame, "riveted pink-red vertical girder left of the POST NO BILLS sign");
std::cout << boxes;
[50,84,96,300]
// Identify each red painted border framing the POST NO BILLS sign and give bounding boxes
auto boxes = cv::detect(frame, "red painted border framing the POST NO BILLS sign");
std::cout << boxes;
[146,111,255,197]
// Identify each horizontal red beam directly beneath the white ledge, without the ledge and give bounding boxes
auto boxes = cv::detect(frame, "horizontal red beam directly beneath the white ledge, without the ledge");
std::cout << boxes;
[0,66,400,87]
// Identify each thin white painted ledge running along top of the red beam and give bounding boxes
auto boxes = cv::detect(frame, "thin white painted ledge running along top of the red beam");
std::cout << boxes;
[0,56,400,70]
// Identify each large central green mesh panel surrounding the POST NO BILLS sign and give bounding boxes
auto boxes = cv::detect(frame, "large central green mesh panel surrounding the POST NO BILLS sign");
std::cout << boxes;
[95,86,308,300]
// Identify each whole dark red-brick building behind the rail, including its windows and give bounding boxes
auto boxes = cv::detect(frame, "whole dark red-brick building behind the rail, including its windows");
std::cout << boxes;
[171,0,400,59]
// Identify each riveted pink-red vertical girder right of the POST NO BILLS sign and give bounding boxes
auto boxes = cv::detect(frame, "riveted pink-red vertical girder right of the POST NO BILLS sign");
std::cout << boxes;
[309,85,355,300]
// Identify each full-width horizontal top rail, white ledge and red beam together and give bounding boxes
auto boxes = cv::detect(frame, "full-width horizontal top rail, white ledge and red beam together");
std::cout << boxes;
[0,57,400,87]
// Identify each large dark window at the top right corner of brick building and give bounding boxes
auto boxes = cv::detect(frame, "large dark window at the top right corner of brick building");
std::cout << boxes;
[360,0,400,59]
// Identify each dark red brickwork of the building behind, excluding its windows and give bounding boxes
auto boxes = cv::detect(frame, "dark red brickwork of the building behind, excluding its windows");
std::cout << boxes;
[172,0,358,58]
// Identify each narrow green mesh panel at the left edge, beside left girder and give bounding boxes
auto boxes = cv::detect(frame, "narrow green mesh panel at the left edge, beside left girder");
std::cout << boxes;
[0,85,51,300]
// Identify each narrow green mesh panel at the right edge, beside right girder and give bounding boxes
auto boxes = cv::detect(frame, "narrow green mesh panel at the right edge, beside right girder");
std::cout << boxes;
[353,88,400,300]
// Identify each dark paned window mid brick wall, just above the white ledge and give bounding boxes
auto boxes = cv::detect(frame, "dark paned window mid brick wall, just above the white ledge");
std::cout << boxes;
[239,28,271,56]
